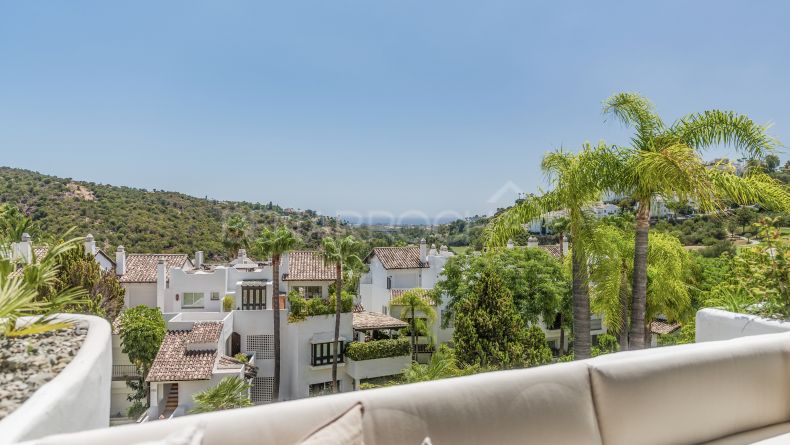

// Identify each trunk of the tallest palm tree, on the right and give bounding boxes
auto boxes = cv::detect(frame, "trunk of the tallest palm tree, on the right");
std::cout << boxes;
[628,198,650,349]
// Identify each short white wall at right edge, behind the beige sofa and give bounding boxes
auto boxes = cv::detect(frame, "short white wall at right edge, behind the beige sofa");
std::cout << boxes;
[695,309,790,343]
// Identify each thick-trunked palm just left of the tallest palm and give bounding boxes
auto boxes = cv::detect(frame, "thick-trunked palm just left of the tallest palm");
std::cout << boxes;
[486,143,622,359]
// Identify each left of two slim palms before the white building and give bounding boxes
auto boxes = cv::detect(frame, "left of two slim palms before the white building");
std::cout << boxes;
[255,226,299,400]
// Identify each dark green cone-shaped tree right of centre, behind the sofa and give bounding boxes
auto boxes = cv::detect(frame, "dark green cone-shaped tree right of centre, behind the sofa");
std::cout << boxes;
[453,268,528,368]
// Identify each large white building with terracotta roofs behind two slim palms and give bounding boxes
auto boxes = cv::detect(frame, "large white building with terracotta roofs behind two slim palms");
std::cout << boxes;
[111,247,409,420]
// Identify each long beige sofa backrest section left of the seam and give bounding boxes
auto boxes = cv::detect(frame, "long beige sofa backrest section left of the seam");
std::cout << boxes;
[24,363,601,445]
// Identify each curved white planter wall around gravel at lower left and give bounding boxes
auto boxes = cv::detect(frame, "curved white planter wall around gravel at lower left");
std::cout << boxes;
[0,314,112,444]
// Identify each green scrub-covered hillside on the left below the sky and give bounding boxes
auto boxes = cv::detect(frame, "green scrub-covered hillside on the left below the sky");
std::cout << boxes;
[0,167,355,258]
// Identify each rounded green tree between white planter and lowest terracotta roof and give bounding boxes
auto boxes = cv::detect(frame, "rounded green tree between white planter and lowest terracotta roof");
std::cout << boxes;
[119,305,166,404]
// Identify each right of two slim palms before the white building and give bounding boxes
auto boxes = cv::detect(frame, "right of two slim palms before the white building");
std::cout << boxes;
[321,236,362,392]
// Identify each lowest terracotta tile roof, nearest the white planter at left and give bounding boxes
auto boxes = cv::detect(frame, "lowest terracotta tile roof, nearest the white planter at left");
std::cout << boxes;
[146,331,217,382]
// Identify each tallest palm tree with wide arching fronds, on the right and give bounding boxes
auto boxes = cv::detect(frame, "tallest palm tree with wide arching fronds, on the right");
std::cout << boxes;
[603,93,788,349]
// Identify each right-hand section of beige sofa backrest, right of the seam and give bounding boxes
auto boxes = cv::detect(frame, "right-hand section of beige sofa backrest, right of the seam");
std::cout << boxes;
[588,334,790,445]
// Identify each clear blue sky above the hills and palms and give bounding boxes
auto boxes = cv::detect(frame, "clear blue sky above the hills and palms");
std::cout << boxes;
[0,0,790,220]
